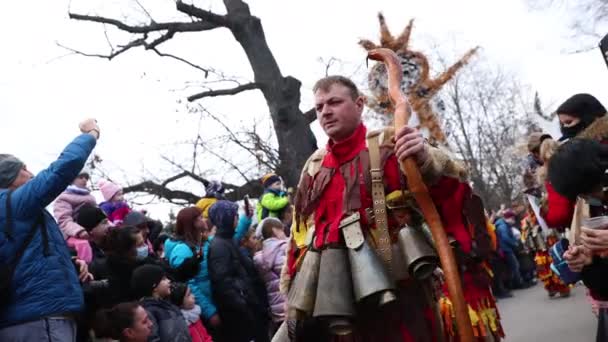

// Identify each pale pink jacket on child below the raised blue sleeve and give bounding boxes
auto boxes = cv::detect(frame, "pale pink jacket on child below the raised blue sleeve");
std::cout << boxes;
[53,188,97,239]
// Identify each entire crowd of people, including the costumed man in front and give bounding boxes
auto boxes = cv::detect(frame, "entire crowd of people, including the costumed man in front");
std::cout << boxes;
[0,76,608,342]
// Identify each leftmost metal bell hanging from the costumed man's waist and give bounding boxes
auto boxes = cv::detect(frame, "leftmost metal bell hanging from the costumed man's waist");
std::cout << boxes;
[287,250,321,319]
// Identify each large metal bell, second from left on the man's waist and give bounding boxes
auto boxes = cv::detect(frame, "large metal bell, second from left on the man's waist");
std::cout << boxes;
[313,248,355,335]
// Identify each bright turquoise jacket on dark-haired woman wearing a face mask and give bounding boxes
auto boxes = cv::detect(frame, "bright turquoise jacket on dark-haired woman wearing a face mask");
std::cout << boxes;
[165,238,217,320]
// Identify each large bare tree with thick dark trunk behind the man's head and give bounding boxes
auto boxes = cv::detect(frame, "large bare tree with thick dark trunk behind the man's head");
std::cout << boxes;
[66,0,317,199]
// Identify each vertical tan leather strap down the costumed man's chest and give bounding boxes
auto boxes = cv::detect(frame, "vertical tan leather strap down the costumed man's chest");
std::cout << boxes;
[367,135,392,273]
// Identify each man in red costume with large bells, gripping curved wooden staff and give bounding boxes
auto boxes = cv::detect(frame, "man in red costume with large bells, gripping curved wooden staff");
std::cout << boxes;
[281,76,503,342]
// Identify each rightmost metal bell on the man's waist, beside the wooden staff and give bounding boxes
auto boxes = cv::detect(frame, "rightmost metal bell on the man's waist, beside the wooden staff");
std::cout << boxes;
[399,226,439,280]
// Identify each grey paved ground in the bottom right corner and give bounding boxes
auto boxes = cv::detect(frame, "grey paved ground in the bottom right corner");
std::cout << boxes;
[498,283,597,342]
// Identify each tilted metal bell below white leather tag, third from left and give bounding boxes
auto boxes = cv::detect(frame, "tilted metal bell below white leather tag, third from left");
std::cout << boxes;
[348,241,397,305]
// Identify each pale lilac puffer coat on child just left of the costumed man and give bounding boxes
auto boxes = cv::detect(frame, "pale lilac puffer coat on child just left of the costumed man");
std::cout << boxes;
[253,238,288,322]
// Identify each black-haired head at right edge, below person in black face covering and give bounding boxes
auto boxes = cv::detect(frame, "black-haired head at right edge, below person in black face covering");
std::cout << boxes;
[548,139,608,199]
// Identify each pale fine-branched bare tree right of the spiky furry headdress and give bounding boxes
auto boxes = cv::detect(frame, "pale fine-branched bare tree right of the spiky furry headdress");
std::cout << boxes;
[441,58,536,208]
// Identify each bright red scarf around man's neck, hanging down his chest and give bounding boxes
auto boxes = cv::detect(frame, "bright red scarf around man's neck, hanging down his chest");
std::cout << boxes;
[314,124,367,248]
